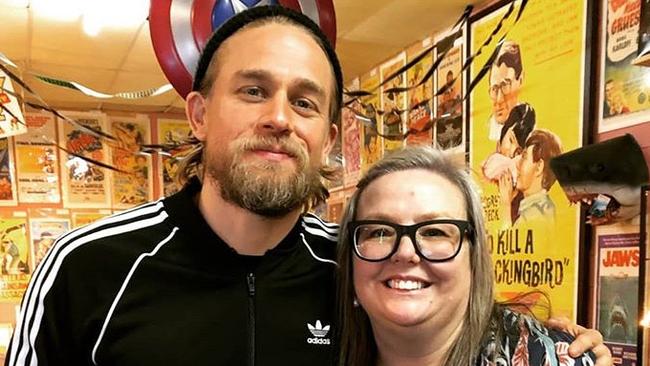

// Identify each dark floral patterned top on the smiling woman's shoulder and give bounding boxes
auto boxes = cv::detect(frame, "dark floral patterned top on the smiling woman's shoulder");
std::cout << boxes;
[476,310,595,366]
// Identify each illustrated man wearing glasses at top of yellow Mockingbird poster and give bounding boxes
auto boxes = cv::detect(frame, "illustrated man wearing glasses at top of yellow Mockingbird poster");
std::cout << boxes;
[488,41,524,141]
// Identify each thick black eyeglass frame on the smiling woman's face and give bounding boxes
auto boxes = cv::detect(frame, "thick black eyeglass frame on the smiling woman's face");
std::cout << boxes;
[348,219,474,263]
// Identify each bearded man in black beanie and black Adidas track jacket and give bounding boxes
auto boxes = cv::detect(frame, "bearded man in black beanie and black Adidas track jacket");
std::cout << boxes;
[7,7,608,366]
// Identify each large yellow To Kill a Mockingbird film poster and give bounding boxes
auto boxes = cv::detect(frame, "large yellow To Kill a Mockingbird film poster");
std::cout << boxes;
[469,0,587,319]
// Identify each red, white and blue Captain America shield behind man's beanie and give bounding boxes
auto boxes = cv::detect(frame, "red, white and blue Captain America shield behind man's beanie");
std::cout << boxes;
[149,0,336,98]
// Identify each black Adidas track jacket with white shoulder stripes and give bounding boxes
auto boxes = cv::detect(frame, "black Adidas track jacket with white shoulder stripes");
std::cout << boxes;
[5,181,338,366]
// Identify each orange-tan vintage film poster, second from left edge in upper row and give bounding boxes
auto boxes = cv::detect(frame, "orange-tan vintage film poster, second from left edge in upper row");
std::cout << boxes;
[14,112,61,203]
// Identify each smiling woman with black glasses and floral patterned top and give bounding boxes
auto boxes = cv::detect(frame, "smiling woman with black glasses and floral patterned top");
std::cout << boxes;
[338,147,593,366]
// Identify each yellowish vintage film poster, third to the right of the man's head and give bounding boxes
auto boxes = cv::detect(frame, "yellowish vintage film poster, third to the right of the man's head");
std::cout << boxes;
[379,52,408,154]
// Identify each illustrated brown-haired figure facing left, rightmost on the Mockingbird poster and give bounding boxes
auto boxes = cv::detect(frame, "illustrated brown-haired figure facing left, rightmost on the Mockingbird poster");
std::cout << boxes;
[515,130,562,224]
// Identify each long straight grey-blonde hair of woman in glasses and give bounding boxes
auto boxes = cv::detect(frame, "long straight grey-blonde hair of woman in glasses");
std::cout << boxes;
[337,146,494,365]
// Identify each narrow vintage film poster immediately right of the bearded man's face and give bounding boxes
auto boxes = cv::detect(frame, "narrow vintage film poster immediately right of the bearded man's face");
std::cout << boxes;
[341,78,362,186]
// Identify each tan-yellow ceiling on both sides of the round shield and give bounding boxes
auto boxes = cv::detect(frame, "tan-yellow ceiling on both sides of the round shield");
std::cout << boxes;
[0,0,477,112]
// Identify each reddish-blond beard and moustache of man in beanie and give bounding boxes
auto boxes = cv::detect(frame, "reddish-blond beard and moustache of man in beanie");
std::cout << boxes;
[203,136,323,217]
